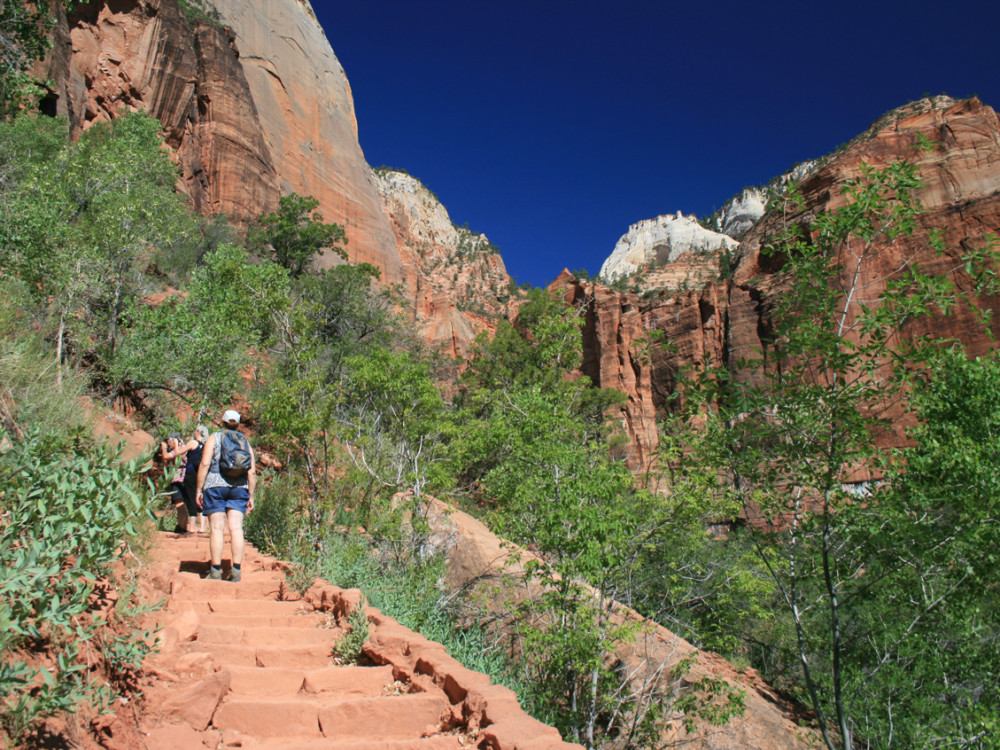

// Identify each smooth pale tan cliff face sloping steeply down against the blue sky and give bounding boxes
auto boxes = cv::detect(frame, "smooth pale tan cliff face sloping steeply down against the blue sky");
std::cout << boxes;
[212,0,403,284]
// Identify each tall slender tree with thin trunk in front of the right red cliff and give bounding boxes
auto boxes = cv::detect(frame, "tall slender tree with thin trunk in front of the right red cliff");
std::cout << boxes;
[688,162,997,750]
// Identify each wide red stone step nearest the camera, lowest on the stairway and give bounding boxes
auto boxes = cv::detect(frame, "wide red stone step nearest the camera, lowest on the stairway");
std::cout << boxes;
[212,693,448,741]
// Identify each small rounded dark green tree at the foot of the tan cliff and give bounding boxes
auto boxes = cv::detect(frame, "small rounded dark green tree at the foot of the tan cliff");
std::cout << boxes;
[249,193,347,278]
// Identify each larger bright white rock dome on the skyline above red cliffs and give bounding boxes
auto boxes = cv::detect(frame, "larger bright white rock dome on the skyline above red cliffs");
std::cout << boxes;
[600,213,739,281]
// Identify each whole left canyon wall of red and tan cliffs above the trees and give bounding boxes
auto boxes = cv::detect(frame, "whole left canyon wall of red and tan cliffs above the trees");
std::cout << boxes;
[38,0,509,354]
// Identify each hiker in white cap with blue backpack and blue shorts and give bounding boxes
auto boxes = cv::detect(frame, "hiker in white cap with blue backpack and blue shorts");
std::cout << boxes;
[196,409,257,582]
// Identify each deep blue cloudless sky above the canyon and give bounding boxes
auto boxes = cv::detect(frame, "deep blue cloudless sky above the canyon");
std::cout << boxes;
[313,0,1000,286]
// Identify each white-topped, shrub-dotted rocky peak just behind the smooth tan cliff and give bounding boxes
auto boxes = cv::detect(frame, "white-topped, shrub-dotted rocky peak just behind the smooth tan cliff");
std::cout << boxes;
[373,170,511,356]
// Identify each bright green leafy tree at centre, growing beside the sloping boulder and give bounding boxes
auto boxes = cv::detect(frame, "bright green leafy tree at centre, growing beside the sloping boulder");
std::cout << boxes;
[450,290,741,747]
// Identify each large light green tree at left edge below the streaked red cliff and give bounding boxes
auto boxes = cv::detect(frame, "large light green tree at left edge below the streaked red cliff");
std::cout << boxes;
[0,113,197,376]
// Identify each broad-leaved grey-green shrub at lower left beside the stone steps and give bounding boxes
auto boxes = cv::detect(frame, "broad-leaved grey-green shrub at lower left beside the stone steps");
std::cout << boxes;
[0,427,156,740]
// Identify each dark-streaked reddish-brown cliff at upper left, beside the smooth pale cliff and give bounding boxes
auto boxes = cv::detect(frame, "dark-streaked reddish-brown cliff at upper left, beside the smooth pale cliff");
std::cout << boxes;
[39,0,278,222]
